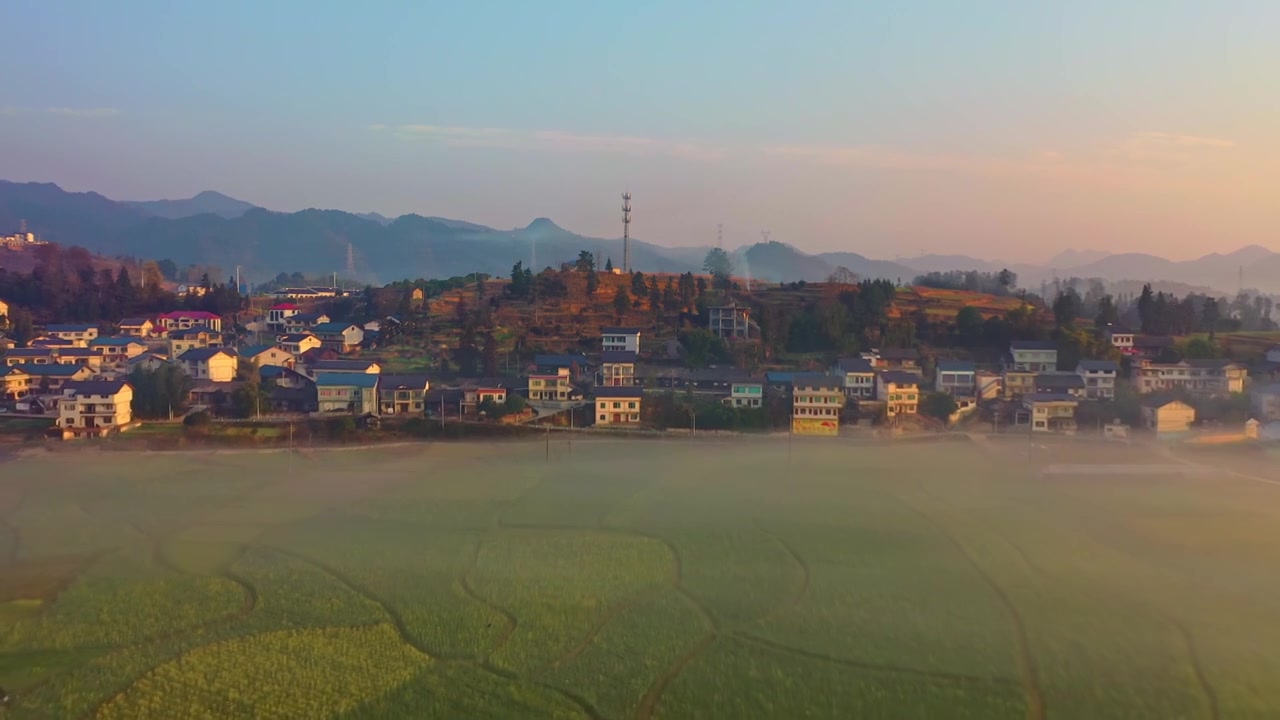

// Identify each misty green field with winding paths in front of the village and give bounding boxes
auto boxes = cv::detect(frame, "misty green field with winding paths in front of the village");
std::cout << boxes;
[0,439,1280,720]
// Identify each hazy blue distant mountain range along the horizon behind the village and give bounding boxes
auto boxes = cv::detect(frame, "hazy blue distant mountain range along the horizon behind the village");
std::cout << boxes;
[0,181,1280,292]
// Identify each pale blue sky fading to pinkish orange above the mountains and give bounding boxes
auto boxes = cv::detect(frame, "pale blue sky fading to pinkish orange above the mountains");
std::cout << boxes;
[0,0,1280,261]
